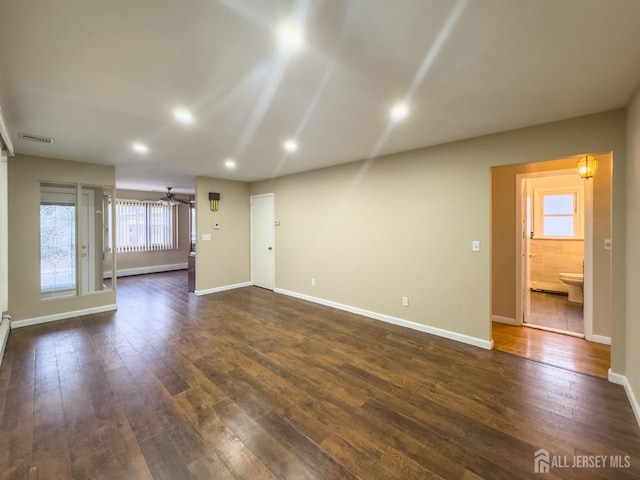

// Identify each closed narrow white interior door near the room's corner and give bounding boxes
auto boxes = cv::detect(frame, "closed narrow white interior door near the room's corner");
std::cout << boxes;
[251,193,275,290]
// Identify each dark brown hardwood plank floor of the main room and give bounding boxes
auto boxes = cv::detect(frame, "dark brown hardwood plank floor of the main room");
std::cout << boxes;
[0,272,640,480]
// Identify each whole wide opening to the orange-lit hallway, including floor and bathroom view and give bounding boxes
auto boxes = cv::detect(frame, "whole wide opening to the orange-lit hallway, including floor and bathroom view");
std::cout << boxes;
[491,152,613,377]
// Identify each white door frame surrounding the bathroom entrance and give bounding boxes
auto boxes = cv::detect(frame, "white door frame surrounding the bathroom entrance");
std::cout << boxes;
[515,169,594,340]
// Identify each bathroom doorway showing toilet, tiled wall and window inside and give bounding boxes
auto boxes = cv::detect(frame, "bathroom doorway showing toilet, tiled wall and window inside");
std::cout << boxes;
[516,169,593,338]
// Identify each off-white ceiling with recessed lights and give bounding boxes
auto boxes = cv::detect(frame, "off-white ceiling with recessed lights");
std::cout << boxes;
[0,0,640,192]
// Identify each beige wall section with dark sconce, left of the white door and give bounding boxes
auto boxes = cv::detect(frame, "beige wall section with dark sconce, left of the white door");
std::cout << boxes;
[196,177,251,292]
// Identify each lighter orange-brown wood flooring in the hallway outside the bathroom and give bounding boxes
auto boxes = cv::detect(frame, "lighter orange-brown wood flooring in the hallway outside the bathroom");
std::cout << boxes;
[492,322,611,378]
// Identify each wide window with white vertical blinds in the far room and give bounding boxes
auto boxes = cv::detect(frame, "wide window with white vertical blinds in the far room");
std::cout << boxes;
[116,200,178,253]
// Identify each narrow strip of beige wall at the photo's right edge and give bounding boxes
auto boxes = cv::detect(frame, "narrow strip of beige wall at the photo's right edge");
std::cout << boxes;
[624,88,640,414]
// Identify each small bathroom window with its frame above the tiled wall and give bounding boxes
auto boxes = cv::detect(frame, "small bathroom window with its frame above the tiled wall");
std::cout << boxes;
[533,188,584,239]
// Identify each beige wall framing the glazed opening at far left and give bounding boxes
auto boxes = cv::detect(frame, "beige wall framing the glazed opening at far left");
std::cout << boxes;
[8,155,116,320]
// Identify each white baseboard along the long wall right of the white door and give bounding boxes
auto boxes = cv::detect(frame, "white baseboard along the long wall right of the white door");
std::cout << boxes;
[273,288,491,350]
